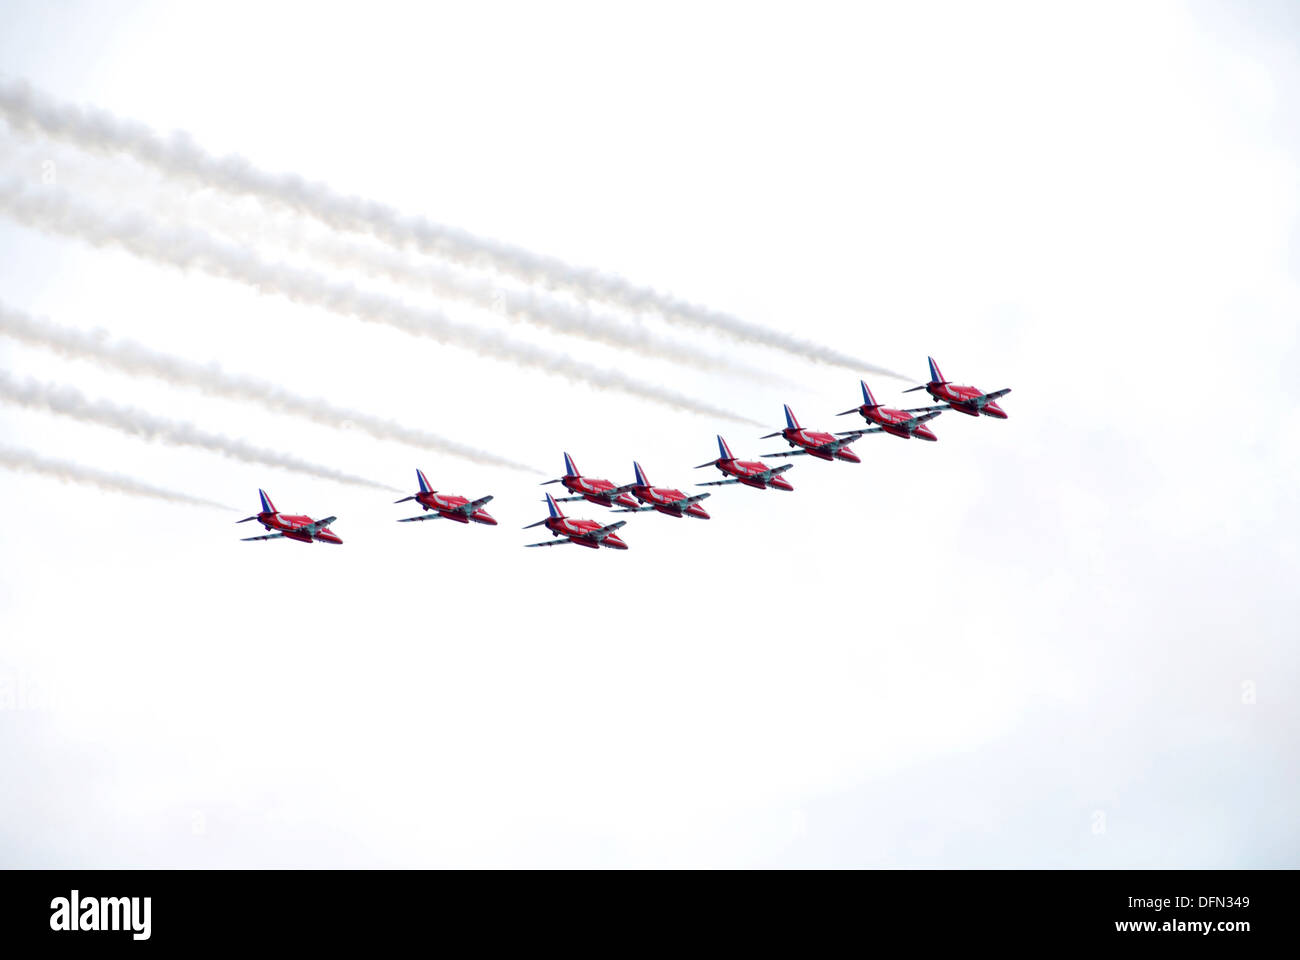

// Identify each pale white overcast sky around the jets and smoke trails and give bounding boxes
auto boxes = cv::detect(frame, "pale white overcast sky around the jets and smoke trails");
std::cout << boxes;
[0,1,1300,866]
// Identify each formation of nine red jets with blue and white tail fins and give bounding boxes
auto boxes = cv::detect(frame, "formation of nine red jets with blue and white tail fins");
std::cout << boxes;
[238,358,1010,550]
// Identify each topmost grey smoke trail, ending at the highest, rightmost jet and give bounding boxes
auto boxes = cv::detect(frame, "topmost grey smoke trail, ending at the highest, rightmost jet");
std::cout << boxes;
[0,82,910,380]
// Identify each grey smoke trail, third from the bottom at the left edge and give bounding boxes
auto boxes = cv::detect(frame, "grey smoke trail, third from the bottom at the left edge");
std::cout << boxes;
[0,303,540,473]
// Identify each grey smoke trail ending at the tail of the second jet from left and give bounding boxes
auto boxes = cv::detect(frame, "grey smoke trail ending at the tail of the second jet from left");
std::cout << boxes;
[0,371,402,493]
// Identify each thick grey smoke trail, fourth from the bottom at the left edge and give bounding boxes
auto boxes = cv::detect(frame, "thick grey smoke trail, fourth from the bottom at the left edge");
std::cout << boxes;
[0,180,762,427]
